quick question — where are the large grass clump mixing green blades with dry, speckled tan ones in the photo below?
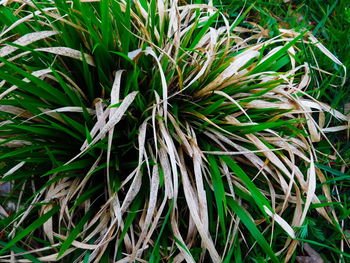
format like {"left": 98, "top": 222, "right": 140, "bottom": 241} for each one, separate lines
{"left": 0, "top": 0, "right": 349, "bottom": 262}
